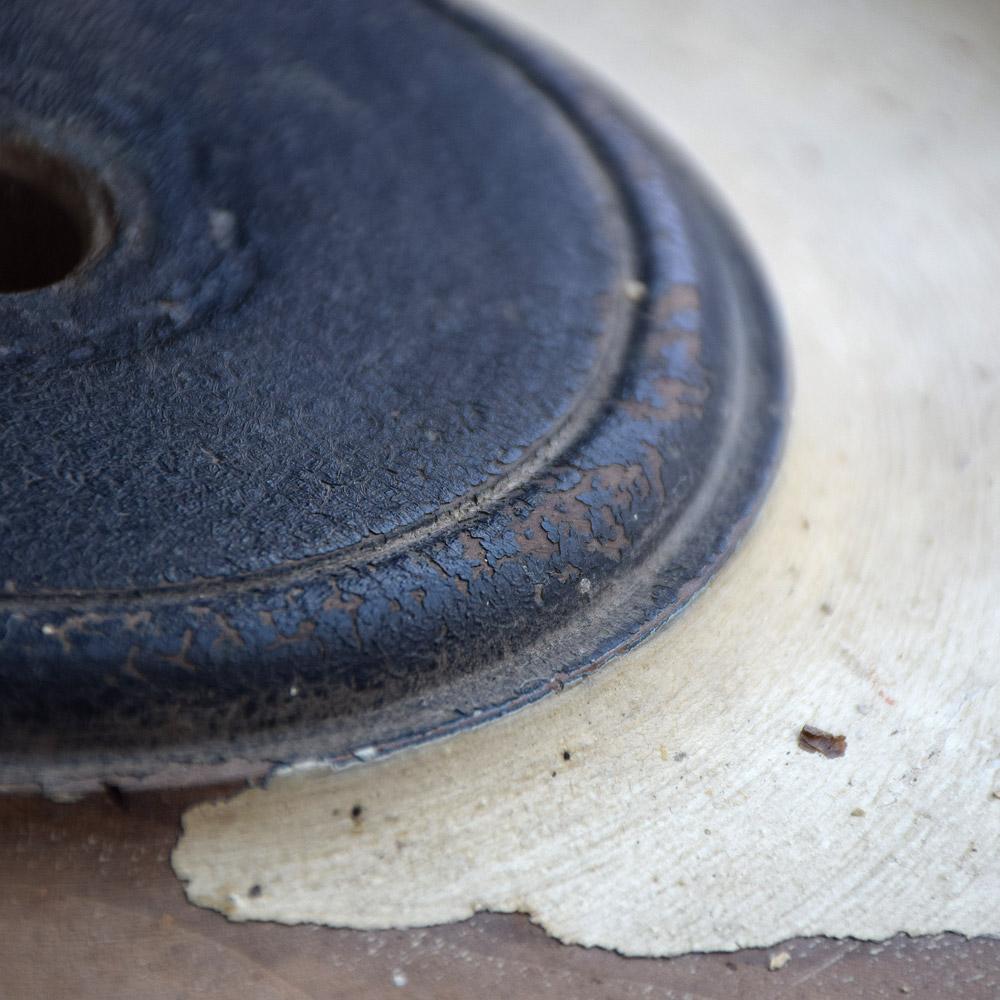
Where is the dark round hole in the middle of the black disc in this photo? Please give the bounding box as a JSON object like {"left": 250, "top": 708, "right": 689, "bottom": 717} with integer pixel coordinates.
{"left": 0, "top": 143, "right": 110, "bottom": 293}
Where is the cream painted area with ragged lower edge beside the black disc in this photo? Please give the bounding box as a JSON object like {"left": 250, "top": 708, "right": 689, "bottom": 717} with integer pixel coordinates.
{"left": 173, "top": 0, "right": 1000, "bottom": 955}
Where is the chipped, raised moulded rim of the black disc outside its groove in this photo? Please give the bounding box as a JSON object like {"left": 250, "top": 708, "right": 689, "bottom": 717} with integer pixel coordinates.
{"left": 0, "top": 0, "right": 788, "bottom": 794}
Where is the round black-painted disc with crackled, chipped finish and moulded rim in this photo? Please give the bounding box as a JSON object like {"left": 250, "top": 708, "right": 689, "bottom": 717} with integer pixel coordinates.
{"left": 0, "top": 0, "right": 784, "bottom": 790}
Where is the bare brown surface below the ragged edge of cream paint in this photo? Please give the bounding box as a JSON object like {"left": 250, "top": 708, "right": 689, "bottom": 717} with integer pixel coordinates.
{"left": 0, "top": 788, "right": 1000, "bottom": 1000}
